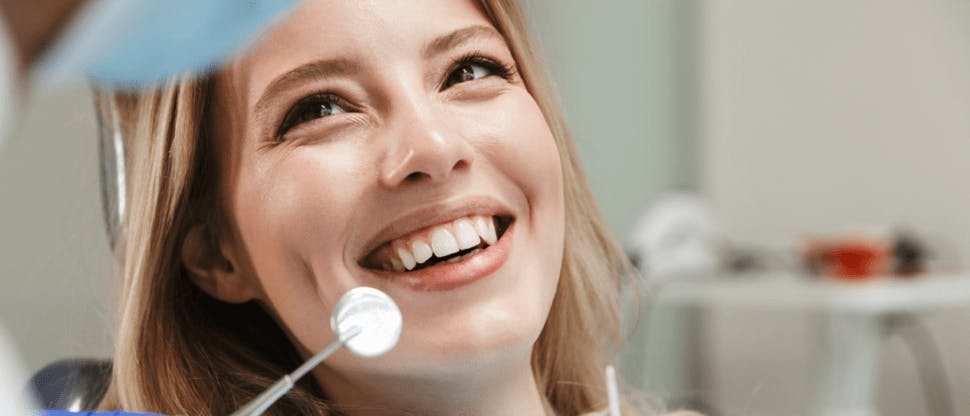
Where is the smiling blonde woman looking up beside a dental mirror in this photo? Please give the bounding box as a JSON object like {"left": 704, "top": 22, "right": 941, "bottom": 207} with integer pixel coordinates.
{"left": 96, "top": 0, "right": 644, "bottom": 415}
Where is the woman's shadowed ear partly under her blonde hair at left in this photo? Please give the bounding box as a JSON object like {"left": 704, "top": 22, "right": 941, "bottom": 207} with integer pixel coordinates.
{"left": 182, "top": 224, "right": 259, "bottom": 303}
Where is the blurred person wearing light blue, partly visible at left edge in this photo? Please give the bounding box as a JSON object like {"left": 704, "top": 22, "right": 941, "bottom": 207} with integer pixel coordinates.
{"left": 0, "top": 0, "right": 295, "bottom": 414}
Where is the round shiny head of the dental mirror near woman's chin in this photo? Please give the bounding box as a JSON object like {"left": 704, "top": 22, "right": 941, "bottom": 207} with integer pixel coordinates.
{"left": 330, "top": 286, "right": 402, "bottom": 357}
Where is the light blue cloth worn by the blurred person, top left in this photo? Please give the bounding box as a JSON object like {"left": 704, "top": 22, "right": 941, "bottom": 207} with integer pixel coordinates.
{"left": 36, "top": 0, "right": 296, "bottom": 87}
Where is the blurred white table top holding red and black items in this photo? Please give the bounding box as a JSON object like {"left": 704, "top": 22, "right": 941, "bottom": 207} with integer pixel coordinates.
{"left": 645, "top": 274, "right": 970, "bottom": 314}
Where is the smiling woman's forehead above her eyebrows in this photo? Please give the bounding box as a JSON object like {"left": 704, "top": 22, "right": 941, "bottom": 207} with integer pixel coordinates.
{"left": 233, "top": 0, "right": 491, "bottom": 105}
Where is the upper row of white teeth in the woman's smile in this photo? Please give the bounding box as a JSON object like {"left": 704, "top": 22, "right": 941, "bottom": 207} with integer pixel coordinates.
{"left": 385, "top": 215, "right": 498, "bottom": 272}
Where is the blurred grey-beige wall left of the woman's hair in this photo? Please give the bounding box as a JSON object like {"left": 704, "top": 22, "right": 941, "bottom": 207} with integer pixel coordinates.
{"left": 0, "top": 85, "right": 113, "bottom": 371}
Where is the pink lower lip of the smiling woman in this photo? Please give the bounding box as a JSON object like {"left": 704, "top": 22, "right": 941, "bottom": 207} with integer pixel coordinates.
{"left": 372, "top": 222, "right": 515, "bottom": 292}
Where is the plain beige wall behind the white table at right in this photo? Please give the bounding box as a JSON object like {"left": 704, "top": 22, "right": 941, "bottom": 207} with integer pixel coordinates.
{"left": 698, "top": 0, "right": 970, "bottom": 415}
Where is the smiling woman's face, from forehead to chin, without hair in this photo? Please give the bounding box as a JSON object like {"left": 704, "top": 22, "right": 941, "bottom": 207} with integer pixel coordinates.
{"left": 210, "top": 0, "right": 564, "bottom": 376}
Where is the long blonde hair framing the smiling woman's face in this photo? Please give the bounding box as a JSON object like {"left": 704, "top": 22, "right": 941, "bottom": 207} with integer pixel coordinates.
{"left": 100, "top": 0, "right": 632, "bottom": 415}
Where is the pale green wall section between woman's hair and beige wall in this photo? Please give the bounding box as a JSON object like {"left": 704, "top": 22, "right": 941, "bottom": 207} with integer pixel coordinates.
{"left": 525, "top": 0, "right": 696, "bottom": 243}
